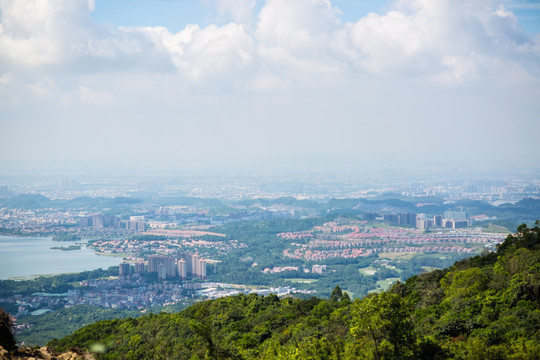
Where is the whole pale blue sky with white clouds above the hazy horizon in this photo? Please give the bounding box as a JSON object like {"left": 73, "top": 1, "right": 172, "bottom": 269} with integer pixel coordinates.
{"left": 0, "top": 0, "right": 540, "bottom": 174}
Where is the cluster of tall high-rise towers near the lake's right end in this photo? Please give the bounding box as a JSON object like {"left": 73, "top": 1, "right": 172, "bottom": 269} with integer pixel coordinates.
{"left": 118, "top": 254, "right": 212, "bottom": 280}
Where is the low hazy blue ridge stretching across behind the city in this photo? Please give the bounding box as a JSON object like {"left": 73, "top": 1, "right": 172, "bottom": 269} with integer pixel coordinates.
{"left": 0, "top": 194, "right": 540, "bottom": 225}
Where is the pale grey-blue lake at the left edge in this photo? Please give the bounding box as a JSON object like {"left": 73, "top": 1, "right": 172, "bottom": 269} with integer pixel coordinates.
{"left": 0, "top": 236, "right": 122, "bottom": 279}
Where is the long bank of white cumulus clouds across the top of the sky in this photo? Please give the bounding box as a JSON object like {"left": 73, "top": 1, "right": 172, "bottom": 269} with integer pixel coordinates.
{"left": 0, "top": 0, "right": 540, "bottom": 84}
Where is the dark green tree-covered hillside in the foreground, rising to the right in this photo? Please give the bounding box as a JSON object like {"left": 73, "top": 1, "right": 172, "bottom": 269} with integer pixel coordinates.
{"left": 49, "top": 222, "right": 540, "bottom": 359}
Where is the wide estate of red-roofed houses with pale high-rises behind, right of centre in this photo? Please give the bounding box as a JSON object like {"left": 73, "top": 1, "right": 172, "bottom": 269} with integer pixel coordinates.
{"left": 278, "top": 219, "right": 506, "bottom": 262}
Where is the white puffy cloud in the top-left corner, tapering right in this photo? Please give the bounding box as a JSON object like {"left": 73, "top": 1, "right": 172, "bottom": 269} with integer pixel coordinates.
{"left": 0, "top": 0, "right": 171, "bottom": 72}
